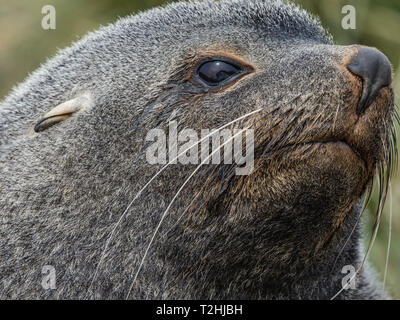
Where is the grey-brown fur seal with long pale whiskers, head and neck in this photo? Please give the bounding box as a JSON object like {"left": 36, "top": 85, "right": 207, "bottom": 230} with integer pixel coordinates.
{"left": 0, "top": 0, "right": 395, "bottom": 299}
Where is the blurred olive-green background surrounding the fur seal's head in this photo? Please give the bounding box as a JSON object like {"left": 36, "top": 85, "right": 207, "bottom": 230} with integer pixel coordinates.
{"left": 0, "top": 0, "right": 400, "bottom": 299}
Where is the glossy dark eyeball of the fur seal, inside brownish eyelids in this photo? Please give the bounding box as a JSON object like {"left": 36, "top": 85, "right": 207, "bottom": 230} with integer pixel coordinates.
{"left": 198, "top": 60, "right": 241, "bottom": 86}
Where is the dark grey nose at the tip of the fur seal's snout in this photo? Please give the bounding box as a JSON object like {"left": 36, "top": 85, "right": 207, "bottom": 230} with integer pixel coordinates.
{"left": 347, "top": 47, "right": 392, "bottom": 114}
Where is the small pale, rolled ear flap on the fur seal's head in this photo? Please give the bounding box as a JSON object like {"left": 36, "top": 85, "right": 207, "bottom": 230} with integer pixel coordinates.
{"left": 33, "top": 93, "right": 92, "bottom": 132}
